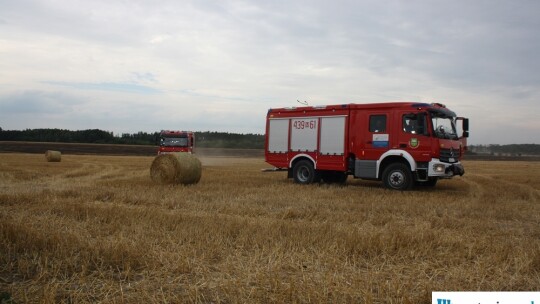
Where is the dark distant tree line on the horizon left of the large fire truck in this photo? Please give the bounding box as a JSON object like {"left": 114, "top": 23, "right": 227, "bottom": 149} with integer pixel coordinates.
{"left": 0, "top": 128, "right": 264, "bottom": 149}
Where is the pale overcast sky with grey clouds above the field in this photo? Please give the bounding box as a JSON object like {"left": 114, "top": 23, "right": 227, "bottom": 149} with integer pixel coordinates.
{"left": 0, "top": 0, "right": 540, "bottom": 144}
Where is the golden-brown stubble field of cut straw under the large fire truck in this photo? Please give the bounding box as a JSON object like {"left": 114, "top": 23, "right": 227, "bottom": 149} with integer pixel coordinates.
{"left": 0, "top": 153, "right": 540, "bottom": 303}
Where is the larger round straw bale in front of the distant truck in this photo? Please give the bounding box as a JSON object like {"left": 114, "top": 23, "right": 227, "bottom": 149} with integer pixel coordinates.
{"left": 150, "top": 153, "right": 202, "bottom": 185}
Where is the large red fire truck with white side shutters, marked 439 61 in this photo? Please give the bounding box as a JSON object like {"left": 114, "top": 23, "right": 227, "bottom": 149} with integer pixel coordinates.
{"left": 265, "top": 102, "right": 469, "bottom": 190}
